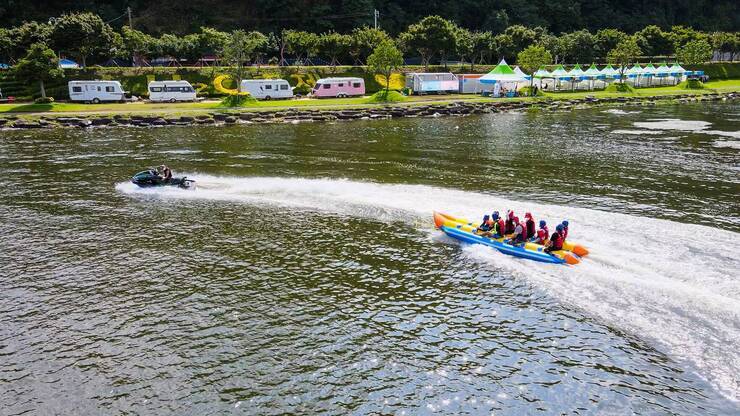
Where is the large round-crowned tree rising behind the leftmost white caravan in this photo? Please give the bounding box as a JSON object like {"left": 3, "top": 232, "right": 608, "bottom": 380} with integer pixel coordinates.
{"left": 49, "top": 13, "right": 116, "bottom": 67}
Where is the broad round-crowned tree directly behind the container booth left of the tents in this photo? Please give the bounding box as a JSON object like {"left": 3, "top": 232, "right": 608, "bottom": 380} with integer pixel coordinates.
{"left": 399, "top": 16, "right": 456, "bottom": 70}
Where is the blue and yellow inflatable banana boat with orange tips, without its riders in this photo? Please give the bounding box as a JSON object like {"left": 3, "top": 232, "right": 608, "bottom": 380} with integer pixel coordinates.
{"left": 434, "top": 212, "right": 581, "bottom": 264}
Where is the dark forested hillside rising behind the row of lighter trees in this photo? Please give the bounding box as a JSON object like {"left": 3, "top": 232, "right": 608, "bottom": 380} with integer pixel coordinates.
{"left": 0, "top": 0, "right": 740, "bottom": 35}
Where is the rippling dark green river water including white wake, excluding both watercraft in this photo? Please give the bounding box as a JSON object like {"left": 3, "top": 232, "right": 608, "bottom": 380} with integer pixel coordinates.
{"left": 0, "top": 103, "right": 740, "bottom": 415}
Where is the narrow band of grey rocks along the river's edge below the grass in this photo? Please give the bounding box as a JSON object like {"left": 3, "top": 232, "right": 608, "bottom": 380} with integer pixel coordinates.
{"left": 0, "top": 92, "right": 740, "bottom": 130}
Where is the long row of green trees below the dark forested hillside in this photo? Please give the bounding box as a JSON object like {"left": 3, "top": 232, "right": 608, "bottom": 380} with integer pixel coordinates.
{"left": 0, "top": 12, "right": 740, "bottom": 70}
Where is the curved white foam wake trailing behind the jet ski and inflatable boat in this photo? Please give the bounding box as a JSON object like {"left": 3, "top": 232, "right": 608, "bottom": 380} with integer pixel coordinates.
{"left": 117, "top": 175, "right": 740, "bottom": 401}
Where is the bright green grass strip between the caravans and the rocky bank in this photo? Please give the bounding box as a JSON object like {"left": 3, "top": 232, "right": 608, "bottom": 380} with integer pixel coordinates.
{"left": 0, "top": 80, "right": 740, "bottom": 114}
